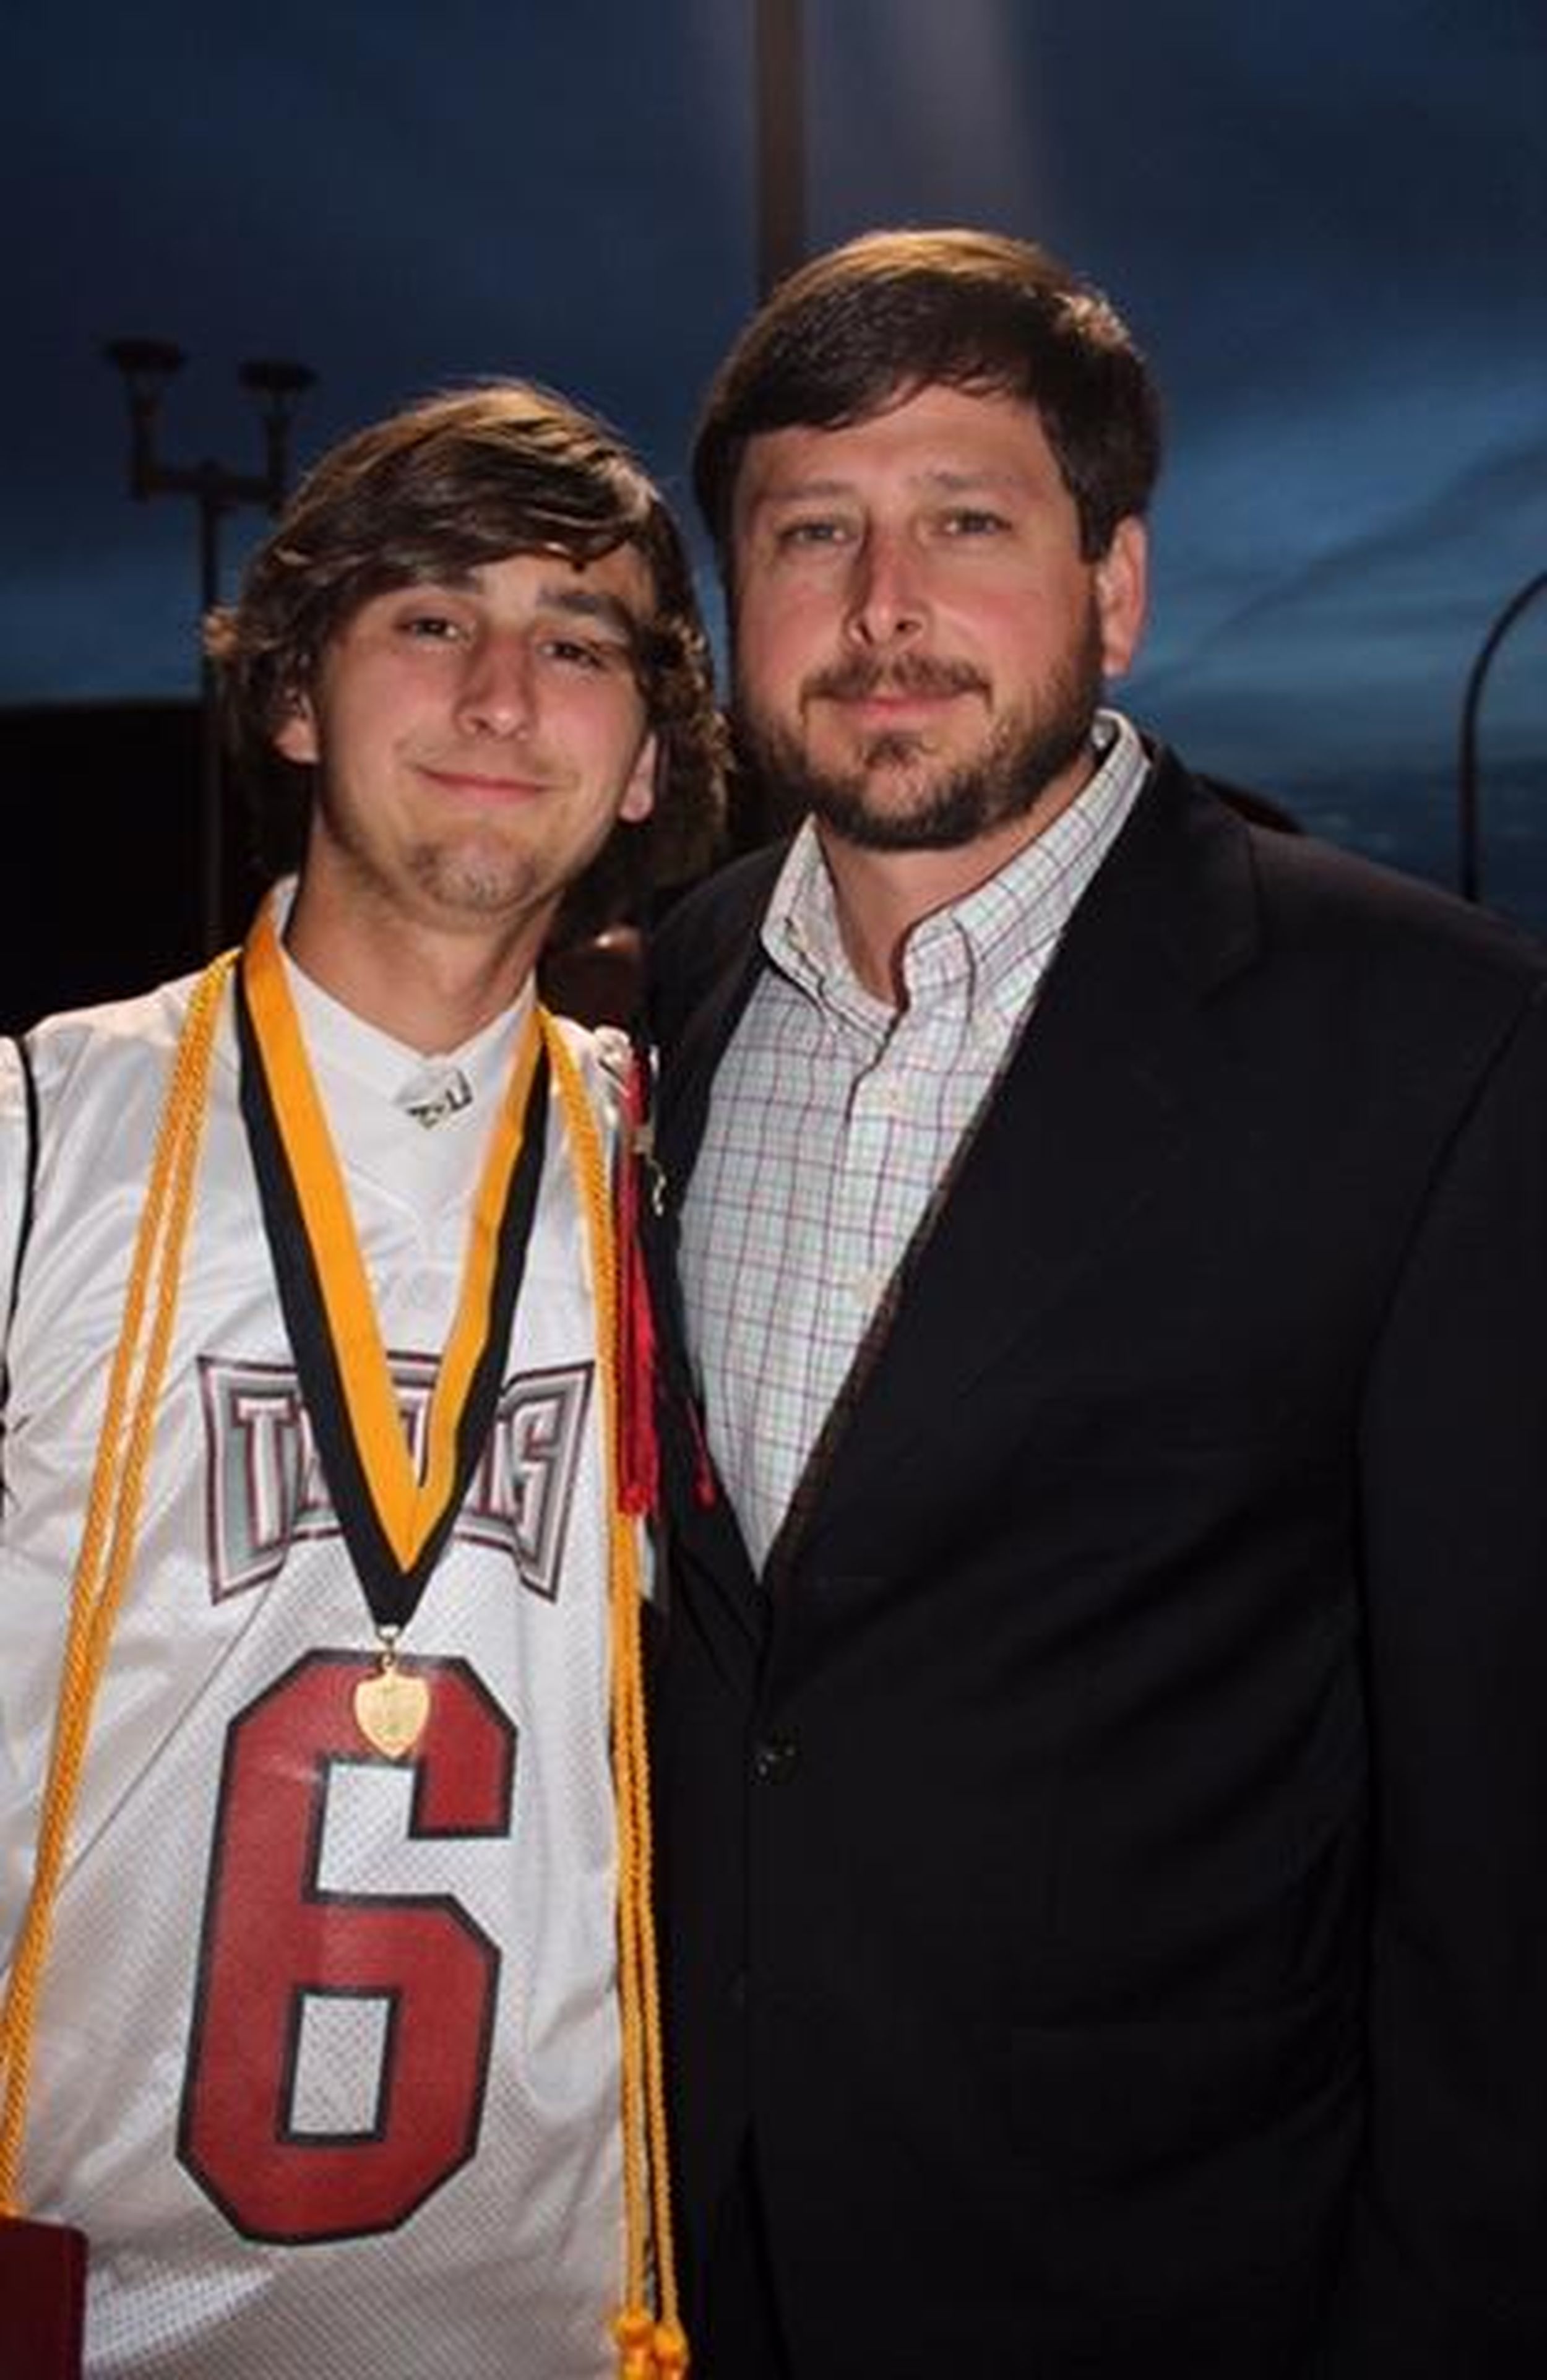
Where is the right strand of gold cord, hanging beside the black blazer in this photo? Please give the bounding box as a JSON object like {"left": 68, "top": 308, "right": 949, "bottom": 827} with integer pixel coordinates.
{"left": 543, "top": 1016, "right": 688, "bottom": 2380}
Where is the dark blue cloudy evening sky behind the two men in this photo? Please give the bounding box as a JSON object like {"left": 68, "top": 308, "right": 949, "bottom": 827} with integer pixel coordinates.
{"left": 0, "top": 0, "right": 1547, "bottom": 928}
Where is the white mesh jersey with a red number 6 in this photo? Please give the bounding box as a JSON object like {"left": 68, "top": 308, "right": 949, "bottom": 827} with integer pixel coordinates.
{"left": 0, "top": 966, "right": 624, "bottom": 2380}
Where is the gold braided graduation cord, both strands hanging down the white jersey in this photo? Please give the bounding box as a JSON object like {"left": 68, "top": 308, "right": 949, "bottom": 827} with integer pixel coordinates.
{"left": 0, "top": 952, "right": 688, "bottom": 2380}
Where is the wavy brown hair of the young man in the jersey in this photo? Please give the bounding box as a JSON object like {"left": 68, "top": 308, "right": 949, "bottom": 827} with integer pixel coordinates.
{"left": 205, "top": 381, "right": 721, "bottom": 878}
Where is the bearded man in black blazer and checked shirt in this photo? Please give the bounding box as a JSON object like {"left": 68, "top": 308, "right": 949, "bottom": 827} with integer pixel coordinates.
{"left": 657, "top": 231, "right": 1547, "bottom": 2380}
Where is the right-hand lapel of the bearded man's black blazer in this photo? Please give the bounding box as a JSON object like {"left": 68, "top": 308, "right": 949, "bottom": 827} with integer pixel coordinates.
{"left": 802, "top": 759, "right": 1257, "bottom": 1547}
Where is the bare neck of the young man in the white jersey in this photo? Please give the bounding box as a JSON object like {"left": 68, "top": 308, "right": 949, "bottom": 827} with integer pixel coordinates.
{"left": 283, "top": 878, "right": 548, "bottom": 1057}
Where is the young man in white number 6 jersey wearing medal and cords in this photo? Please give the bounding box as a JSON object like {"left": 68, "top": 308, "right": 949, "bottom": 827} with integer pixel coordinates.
{"left": 0, "top": 383, "right": 717, "bottom": 2380}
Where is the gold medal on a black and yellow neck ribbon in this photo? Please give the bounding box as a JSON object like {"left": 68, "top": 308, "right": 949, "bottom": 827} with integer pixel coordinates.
{"left": 236, "top": 912, "right": 549, "bottom": 1759}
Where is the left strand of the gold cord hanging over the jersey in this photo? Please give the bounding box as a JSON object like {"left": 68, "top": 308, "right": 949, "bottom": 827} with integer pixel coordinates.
{"left": 0, "top": 952, "right": 236, "bottom": 2216}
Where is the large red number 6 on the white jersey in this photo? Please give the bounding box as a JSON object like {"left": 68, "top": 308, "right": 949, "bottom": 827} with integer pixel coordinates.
{"left": 178, "top": 1652, "right": 517, "bottom": 2242}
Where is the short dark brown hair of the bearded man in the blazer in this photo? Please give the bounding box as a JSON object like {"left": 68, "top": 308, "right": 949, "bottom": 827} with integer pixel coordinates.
{"left": 692, "top": 231, "right": 1161, "bottom": 574}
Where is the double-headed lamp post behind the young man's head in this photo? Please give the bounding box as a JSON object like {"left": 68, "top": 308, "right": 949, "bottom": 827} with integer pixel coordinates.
{"left": 105, "top": 338, "right": 317, "bottom": 954}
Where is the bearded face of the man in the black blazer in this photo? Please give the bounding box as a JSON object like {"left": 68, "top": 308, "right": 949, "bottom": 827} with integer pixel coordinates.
{"left": 733, "top": 386, "right": 1145, "bottom": 871}
